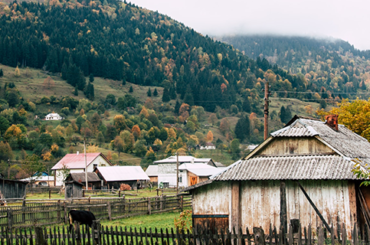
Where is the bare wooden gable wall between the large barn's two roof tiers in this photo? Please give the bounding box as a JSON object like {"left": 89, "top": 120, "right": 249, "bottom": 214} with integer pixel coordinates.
{"left": 257, "top": 138, "right": 334, "bottom": 156}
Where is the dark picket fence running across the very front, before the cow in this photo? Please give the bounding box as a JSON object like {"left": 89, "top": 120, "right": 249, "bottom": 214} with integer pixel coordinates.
{"left": 0, "top": 222, "right": 369, "bottom": 245}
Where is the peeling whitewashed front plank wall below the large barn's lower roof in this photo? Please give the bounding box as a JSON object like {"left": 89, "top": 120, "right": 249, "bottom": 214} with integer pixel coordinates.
{"left": 193, "top": 180, "right": 357, "bottom": 237}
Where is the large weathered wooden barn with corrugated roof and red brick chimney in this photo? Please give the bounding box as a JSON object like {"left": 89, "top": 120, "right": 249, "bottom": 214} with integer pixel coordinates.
{"left": 185, "top": 116, "right": 370, "bottom": 237}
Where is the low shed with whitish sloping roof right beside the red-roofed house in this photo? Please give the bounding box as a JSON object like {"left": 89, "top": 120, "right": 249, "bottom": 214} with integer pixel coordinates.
{"left": 95, "top": 166, "right": 150, "bottom": 189}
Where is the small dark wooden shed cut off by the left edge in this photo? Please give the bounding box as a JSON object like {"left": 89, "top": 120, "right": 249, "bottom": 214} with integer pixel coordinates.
{"left": 0, "top": 177, "right": 29, "bottom": 199}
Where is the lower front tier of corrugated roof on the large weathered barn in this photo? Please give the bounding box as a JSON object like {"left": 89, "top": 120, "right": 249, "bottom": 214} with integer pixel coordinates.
{"left": 211, "top": 156, "right": 356, "bottom": 181}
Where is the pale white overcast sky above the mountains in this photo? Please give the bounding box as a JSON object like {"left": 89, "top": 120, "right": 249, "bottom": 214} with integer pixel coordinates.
{"left": 127, "top": 0, "right": 370, "bottom": 50}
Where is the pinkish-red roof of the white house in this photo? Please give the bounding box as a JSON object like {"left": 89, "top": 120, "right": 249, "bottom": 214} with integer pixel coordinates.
{"left": 52, "top": 152, "right": 112, "bottom": 170}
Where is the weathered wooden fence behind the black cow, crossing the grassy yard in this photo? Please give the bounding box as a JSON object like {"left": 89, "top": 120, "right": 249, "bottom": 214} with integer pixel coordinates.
{"left": 0, "top": 196, "right": 191, "bottom": 229}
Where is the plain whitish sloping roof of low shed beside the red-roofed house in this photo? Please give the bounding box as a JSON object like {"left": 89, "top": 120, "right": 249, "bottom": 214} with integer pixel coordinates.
{"left": 97, "top": 166, "right": 150, "bottom": 181}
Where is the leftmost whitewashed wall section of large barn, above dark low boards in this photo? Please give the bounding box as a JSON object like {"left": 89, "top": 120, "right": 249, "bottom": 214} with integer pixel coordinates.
{"left": 193, "top": 182, "right": 231, "bottom": 215}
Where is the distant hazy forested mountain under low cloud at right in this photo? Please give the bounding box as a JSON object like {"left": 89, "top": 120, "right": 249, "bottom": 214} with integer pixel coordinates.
{"left": 216, "top": 35, "right": 370, "bottom": 99}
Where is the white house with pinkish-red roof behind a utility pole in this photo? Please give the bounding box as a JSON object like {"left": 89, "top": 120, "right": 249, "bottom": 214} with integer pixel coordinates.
{"left": 51, "top": 152, "right": 112, "bottom": 186}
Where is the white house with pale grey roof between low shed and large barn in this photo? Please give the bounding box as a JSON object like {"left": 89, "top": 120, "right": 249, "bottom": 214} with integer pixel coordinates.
{"left": 153, "top": 156, "right": 216, "bottom": 187}
